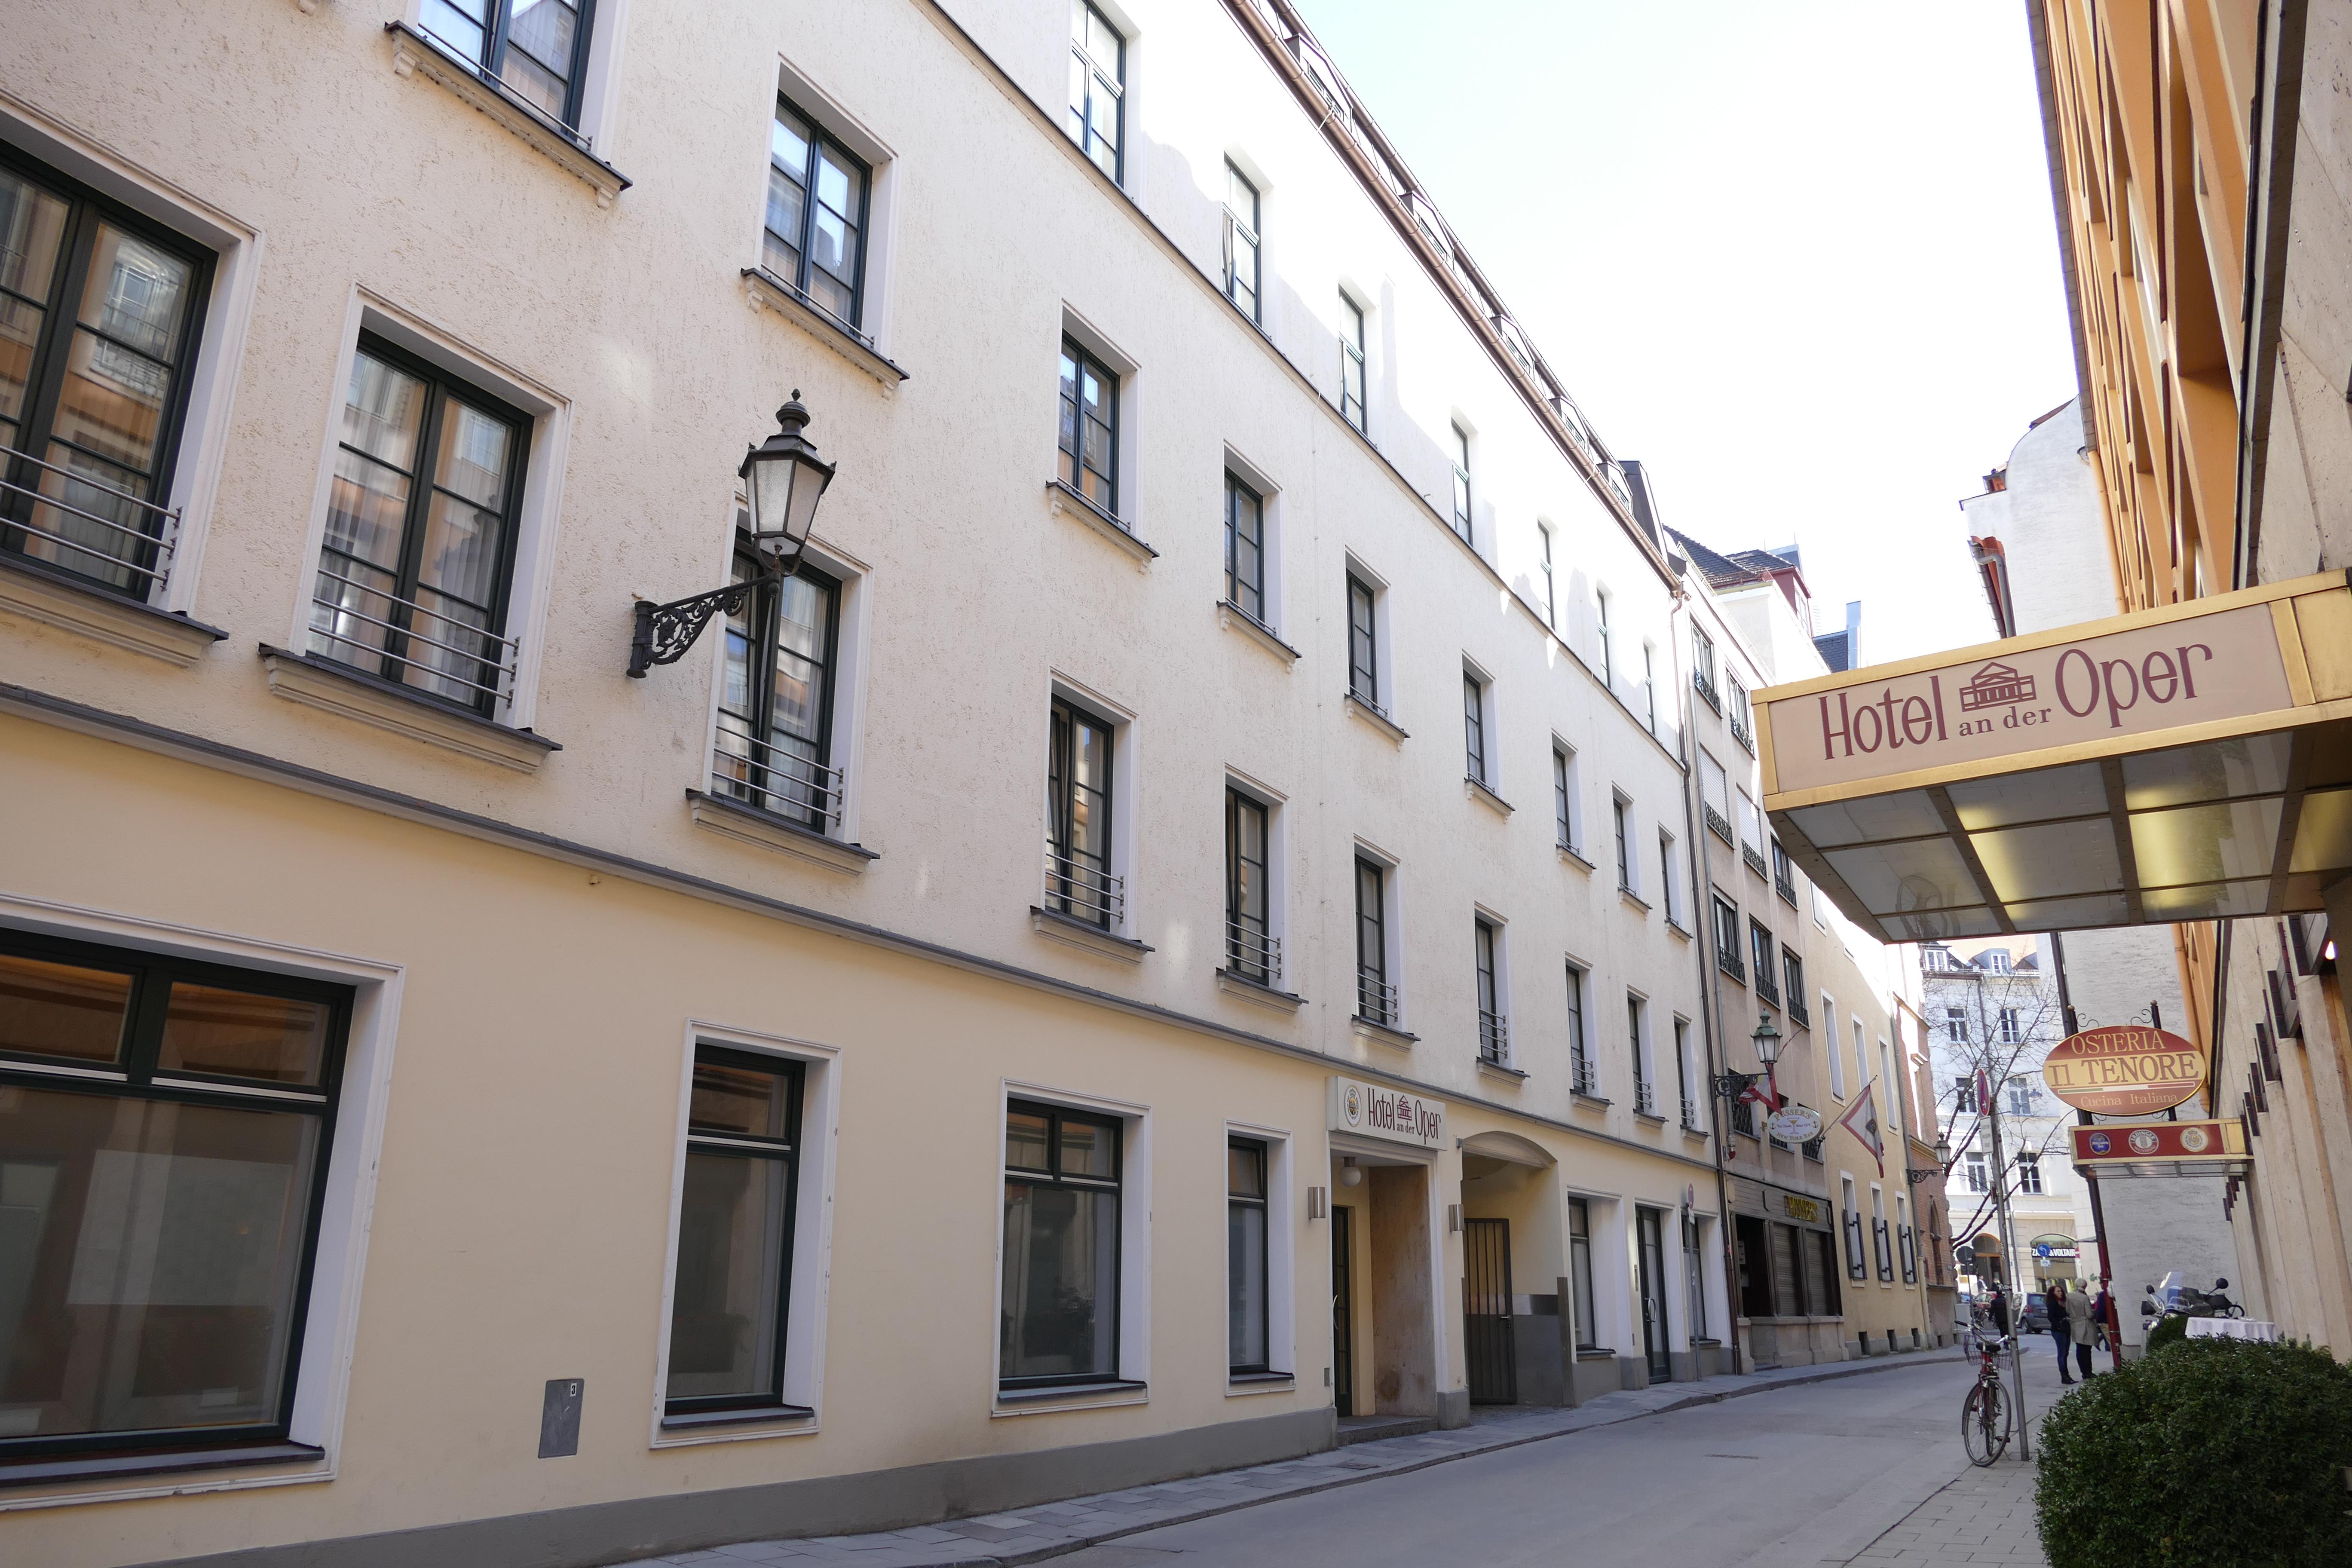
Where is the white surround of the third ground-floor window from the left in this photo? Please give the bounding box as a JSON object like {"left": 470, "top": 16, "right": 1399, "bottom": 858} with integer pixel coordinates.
{"left": 988, "top": 1079, "right": 1152, "bottom": 1420}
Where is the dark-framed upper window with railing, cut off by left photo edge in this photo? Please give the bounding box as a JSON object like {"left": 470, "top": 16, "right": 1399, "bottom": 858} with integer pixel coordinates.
{"left": 0, "top": 153, "right": 211, "bottom": 600}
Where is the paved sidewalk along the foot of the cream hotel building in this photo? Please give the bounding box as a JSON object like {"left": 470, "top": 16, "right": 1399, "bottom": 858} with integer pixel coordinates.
{"left": 626, "top": 1349, "right": 1957, "bottom": 1568}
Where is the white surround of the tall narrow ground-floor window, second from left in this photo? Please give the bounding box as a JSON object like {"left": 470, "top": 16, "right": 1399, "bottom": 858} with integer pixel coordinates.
{"left": 647, "top": 1018, "right": 846, "bottom": 1448}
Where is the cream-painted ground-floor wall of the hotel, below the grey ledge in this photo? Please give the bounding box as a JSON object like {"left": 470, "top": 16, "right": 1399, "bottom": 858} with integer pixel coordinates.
{"left": 0, "top": 717, "right": 1731, "bottom": 1568}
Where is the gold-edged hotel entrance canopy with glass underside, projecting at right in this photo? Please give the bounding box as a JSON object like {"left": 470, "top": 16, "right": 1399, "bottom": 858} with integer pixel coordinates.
{"left": 1755, "top": 571, "right": 2352, "bottom": 943}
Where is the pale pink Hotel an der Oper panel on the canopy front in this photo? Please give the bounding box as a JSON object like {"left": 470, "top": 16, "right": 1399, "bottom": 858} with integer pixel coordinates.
{"left": 1771, "top": 604, "right": 2296, "bottom": 795}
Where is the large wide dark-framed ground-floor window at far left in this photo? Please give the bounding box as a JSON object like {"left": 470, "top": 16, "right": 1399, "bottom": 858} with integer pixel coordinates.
{"left": 0, "top": 936, "right": 350, "bottom": 1472}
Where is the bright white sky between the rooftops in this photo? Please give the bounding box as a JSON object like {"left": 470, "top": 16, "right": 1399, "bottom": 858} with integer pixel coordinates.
{"left": 1301, "top": 0, "right": 2074, "bottom": 663}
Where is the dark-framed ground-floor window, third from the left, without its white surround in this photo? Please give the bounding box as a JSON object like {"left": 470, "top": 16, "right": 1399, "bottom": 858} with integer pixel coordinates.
{"left": 997, "top": 1100, "right": 1122, "bottom": 1389}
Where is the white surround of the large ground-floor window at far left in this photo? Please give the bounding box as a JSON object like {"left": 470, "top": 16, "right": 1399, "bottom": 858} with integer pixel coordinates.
{"left": 0, "top": 893, "right": 407, "bottom": 1514}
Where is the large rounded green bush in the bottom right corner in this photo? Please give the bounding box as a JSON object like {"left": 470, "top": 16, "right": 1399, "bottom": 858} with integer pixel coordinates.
{"left": 2034, "top": 1338, "right": 2352, "bottom": 1568}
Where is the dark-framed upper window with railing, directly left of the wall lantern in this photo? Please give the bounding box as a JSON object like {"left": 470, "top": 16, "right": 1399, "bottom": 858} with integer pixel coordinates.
{"left": 310, "top": 334, "right": 529, "bottom": 715}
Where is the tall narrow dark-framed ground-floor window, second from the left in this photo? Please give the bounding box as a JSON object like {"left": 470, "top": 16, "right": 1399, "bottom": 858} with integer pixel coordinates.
{"left": 666, "top": 1046, "right": 802, "bottom": 1418}
